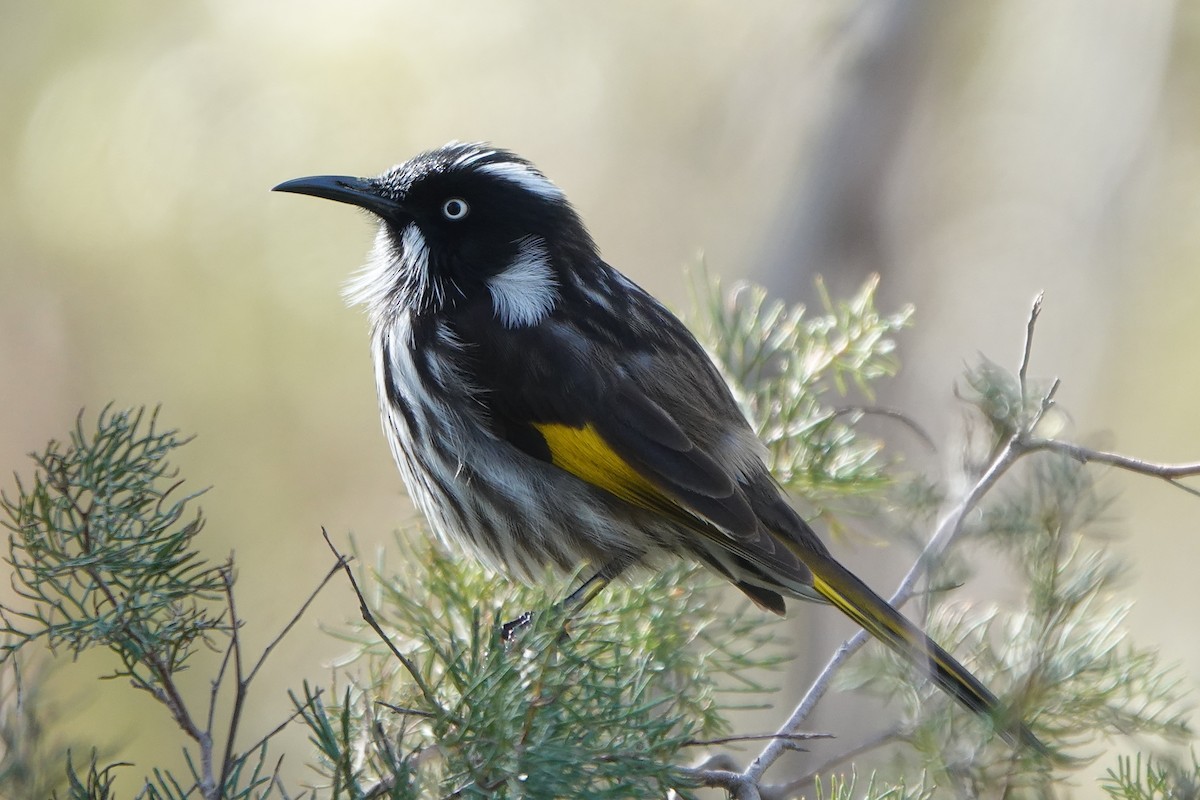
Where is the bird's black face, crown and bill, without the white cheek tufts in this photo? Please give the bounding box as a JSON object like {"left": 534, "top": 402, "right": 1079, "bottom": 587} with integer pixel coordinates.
{"left": 275, "top": 144, "right": 594, "bottom": 287}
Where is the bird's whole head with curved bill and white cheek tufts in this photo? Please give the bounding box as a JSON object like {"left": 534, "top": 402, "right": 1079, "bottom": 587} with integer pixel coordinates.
{"left": 275, "top": 143, "right": 598, "bottom": 327}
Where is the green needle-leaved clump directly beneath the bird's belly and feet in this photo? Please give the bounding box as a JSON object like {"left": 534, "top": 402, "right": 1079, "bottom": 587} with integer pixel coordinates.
{"left": 296, "top": 537, "right": 779, "bottom": 798}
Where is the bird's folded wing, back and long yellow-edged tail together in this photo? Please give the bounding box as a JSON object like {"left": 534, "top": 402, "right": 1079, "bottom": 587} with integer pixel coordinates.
{"left": 446, "top": 287, "right": 1043, "bottom": 750}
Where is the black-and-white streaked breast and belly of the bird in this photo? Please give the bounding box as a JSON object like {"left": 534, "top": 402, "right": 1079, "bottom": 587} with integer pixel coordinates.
{"left": 372, "top": 299, "right": 657, "bottom": 582}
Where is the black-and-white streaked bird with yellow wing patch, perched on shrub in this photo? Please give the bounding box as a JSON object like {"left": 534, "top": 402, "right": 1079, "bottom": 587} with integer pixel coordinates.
{"left": 274, "top": 142, "right": 1045, "bottom": 752}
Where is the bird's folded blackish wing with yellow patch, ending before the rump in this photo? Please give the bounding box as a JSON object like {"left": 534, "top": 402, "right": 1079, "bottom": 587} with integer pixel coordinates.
{"left": 460, "top": 280, "right": 766, "bottom": 541}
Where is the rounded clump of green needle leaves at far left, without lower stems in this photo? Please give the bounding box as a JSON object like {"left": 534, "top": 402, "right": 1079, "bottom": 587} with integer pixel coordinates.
{"left": 0, "top": 409, "right": 227, "bottom": 692}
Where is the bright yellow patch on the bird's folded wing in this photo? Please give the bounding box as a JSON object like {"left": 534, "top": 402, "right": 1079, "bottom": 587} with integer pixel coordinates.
{"left": 533, "top": 422, "right": 683, "bottom": 516}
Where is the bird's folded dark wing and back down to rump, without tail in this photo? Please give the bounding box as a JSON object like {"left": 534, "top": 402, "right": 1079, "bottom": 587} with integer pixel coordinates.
{"left": 441, "top": 278, "right": 822, "bottom": 613}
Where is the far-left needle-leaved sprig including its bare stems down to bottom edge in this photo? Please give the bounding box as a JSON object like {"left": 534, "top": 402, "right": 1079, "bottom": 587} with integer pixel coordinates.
{"left": 0, "top": 409, "right": 282, "bottom": 800}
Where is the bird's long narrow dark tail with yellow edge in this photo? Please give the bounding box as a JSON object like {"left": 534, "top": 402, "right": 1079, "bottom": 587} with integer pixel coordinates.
{"left": 796, "top": 549, "right": 1049, "bottom": 754}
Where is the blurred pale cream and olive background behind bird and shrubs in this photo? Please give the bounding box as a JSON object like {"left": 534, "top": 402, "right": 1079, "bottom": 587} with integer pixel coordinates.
{"left": 0, "top": 0, "right": 1200, "bottom": 798}
